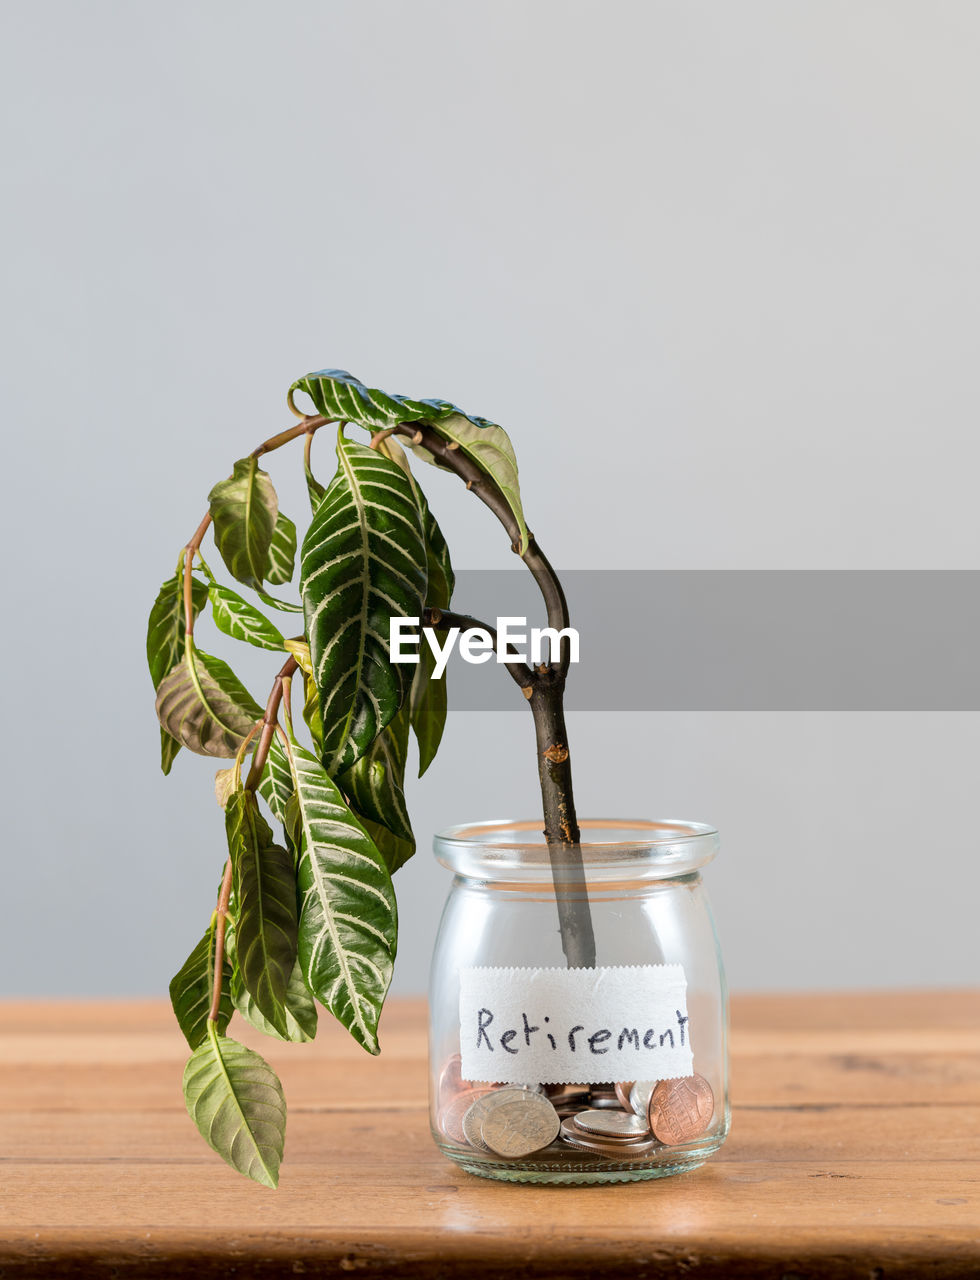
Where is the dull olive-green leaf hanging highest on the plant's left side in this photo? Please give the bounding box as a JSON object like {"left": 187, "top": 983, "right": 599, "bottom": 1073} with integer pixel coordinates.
{"left": 209, "top": 456, "right": 279, "bottom": 586}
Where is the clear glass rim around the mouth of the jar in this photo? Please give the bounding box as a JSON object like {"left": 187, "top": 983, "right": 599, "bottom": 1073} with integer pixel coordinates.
{"left": 432, "top": 818, "right": 719, "bottom": 879}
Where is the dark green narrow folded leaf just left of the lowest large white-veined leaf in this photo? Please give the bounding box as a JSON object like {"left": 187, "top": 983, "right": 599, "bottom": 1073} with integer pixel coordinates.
{"left": 225, "top": 790, "right": 297, "bottom": 1036}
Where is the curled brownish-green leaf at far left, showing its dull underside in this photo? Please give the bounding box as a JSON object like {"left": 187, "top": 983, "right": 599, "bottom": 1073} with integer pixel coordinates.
{"left": 156, "top": 644, "right": 262, "bottom": 756}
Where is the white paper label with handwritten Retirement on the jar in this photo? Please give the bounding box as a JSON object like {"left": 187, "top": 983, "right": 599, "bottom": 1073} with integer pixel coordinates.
{"left": 459, "top": 964, "right": 693, "bottom": 1084}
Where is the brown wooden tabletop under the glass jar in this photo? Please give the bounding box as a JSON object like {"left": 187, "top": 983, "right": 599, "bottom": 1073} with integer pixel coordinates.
{"left": 0, "top": 992, "right": 980, "bottom": 1280}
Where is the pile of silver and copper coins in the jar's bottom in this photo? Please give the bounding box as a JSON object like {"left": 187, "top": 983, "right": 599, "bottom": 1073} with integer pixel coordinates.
{"left": 439, "top": 1053, "right": 714, "bottom": 1162}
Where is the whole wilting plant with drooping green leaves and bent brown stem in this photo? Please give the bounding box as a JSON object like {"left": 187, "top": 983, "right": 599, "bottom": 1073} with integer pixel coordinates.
{"left": 146, "top": 370, "right": 595, "bottom": 1187}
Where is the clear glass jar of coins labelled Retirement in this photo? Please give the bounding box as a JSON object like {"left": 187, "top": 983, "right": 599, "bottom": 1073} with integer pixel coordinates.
{"left": 429, "top": 819, "right": 731, "bottom": 1184}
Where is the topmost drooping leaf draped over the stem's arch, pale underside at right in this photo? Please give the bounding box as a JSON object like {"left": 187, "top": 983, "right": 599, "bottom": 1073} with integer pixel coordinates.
{"left": 289, "top": 369, "right": 528, "bottom": 554}
